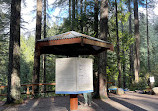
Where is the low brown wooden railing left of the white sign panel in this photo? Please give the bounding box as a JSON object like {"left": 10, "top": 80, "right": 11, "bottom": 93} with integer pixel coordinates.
{"left": 0, "top": 83, "right": 56, "bottom": 96}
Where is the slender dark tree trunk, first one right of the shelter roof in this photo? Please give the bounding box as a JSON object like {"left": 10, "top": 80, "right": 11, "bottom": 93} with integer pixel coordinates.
{"left": 115, "top": 0, "right": 121, "bottom": 87}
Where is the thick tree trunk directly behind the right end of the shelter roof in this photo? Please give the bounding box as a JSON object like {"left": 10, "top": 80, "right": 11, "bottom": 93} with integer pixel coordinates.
{"left": 99, "top": 0, "right": 108, "bottom": 99}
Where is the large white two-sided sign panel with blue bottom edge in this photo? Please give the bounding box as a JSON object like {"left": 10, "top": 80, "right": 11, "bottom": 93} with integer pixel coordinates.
{"left": 56, "top": 58, "right": 93, "bottom": 94}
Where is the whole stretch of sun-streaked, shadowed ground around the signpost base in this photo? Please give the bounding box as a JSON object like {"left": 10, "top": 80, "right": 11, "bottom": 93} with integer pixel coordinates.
{"left": 0, "top": 92, "right": 158, "bottom": 111}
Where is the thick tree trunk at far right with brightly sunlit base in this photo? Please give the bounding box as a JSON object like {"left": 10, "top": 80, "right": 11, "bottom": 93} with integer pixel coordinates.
{"left": 134, "top": 0, "right": 140, "bottom": 83}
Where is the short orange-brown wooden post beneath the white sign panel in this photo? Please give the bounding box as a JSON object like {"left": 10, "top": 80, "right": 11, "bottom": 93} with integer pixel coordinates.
{"left": 70, "top": 94, "right": 78, "bottom": 111}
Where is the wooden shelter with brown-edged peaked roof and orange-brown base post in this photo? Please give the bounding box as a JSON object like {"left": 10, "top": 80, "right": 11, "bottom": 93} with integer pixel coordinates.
{"left": 34, "top": 31, "right": 113, "bottom": 110}
